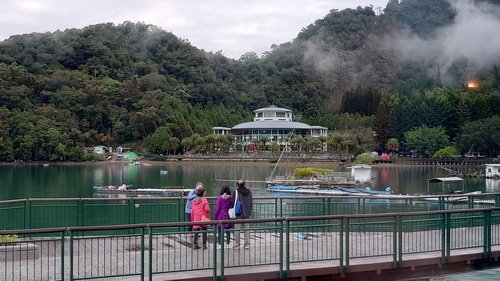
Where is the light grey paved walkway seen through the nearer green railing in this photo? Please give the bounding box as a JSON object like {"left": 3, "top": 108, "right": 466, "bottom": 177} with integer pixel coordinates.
{"left": 0, "top": 225, "right": 500, "bottom": 280}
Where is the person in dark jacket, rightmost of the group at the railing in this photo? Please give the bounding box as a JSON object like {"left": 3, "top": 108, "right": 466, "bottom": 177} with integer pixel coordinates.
{"left": 233, "top": 179, "right": 253, "bottom": 249}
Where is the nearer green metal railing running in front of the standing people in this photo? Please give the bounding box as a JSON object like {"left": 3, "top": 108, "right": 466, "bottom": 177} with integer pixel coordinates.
{"left": 0, "top": 208, "right": 500, "bottom": 280}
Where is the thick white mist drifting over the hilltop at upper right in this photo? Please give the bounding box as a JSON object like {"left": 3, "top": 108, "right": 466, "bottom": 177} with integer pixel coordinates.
{"left": 386, "top": 0, "right": 500, "bottom": 86}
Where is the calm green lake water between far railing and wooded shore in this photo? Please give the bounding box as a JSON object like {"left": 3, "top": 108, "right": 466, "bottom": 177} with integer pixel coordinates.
{"left": 0, "top": 162, "right": 500, "bottom": 200}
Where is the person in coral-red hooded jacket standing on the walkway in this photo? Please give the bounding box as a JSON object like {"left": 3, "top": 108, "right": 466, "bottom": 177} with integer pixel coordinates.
{"left": 191, "top": 187, "right": 210, "bottom": 250}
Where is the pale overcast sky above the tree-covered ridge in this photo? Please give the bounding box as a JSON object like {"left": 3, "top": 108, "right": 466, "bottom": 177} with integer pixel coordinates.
{"left": 0, "top": 0, "right": 387, "bottom": 59}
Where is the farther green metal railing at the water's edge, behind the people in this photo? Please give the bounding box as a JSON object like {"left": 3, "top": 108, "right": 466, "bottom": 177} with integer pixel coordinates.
{"left": 0, "top": 193, "right": 500, "bottom": 230}
